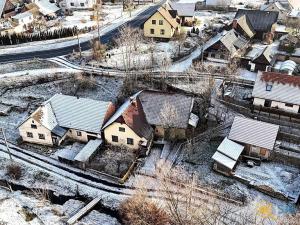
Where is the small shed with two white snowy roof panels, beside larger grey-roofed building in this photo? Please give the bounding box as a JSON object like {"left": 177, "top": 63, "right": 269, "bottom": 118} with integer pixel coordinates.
{"left": 212, "top": 137, "right": 244, "bottom": 176}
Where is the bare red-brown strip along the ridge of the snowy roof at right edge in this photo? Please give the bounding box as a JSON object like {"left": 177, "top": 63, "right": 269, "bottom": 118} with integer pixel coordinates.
{"left": 261, "top": 72, "right": 300, "bottom": 87}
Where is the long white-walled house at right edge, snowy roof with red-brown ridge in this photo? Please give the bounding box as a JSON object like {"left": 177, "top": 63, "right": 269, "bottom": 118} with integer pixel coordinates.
{"left": 252, "top": 72, "right": 300, "bottom": 113}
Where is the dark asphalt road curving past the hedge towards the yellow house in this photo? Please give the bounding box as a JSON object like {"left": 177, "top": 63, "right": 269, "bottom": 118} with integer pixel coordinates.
{"left": 0, "top": 4, "right": 160, "bottom": 63}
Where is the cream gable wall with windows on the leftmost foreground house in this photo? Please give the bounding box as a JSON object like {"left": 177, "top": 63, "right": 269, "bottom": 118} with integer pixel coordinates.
{"left": 19, "top": 118, "right": 53, "bottom": 146}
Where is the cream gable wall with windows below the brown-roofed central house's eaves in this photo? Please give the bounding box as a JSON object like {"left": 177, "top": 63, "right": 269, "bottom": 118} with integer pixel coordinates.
{"left": 104, "top": 122, "right": 146, "bottom": 149}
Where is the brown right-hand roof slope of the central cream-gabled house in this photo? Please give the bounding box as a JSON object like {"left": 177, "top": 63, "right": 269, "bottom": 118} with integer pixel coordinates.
{"left": 118, "top": 97, "right": 153, "bottom": 139}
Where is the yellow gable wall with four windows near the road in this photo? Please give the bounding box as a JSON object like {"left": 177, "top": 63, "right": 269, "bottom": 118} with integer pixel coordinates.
{"left": 144, "top": 12, "right": 175, "bottom": 39}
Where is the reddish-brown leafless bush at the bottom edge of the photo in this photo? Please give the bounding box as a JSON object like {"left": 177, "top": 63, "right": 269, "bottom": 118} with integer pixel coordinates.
{"left": 119, "top": 195, "right": 170, "bottom": 225}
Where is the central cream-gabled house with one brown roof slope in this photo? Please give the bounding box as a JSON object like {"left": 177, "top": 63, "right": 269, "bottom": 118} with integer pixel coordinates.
{"left": 103, "top": 92, "right": 153, "bottom": 150}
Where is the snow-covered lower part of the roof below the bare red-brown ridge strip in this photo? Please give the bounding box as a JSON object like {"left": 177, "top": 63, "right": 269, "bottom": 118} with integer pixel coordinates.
{"left": 252, "top": 72, "right": 300, "bottom": 105}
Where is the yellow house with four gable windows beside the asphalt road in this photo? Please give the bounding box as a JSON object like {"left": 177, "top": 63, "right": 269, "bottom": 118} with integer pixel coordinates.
{"left": 144, "top": 7, "right": 180, "bottom": 39}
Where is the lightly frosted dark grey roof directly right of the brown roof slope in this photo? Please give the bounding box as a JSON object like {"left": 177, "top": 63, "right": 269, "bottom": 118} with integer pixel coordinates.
{"left": 139, "top": 91, "right": 194, "bottom": 128}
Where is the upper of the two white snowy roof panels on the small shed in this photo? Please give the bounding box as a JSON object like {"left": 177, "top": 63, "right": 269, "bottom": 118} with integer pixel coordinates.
{"left": 218, "top": 137, "right": 244, "bottom": 160}
